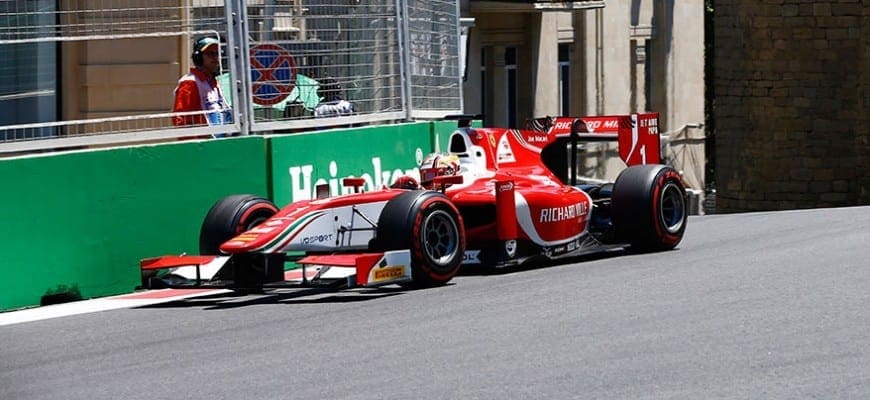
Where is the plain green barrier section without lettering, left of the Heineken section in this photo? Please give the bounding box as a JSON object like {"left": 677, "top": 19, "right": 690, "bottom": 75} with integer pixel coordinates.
{"left": 0, "top": 136, "right": 268, "bottom": 310}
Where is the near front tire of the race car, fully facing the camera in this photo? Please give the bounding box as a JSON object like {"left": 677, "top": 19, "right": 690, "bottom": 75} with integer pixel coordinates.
{"left": 372, "top": 190, "right": 465, "bottom": 288}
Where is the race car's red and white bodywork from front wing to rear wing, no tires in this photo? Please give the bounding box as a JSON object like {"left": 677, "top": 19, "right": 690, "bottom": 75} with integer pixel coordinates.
{"left": 142, "top": 113, "right": 660, "bottom": 285}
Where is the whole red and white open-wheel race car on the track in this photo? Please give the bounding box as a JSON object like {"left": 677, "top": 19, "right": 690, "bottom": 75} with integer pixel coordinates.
{"left": 141, "top": 114, "right": 687, "bottom": 288}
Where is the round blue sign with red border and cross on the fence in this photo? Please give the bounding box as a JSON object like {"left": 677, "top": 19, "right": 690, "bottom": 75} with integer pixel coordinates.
{"left": 251, "top": 44, "right": 296, "bottom": 106}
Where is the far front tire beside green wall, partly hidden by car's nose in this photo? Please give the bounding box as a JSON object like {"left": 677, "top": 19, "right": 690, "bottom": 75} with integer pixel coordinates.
{"left": 199, "top": 194, "right": 284, "bottom": 287}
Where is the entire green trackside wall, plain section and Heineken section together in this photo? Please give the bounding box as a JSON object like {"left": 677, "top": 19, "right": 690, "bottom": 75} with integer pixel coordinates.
{"left": 0, "top": 122, "right": 436, "bottom": 311}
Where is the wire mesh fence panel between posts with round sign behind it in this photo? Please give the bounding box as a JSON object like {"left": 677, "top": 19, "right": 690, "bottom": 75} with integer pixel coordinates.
{"left": 247, "top": 0, "right": 406, "bottom": 129}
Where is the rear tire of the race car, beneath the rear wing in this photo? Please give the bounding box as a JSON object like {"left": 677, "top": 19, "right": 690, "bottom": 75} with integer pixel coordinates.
{"left": 611, "top": 164, "right": 688, "bottom": 252}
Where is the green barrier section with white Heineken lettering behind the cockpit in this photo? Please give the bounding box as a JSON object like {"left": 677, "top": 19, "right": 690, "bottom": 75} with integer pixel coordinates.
{"left": 270, "top": 122, "right": 434, "bottom": 206}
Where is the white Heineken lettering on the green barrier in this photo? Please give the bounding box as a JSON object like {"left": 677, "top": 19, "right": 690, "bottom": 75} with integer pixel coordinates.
{"left": 287, "top": 155, "right": 422, "bottom": 201}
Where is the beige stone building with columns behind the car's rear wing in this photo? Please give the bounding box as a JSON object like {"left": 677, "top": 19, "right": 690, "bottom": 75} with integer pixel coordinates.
{"left": 460, "top": 0, "right": 706, "bottom": 194}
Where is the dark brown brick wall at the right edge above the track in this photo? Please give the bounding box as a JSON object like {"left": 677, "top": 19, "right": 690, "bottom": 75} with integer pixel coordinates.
{"left": 714, "top": 0, "right": 870, "bottom": 212}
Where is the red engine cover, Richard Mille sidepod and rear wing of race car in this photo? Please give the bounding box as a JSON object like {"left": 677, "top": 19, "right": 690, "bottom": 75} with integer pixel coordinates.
{"left": 436, "top": 113, "right": 660, "bottom": 250}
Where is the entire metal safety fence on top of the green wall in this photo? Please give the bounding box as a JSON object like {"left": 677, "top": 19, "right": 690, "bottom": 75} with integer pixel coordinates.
{"left": 0, "top": 0, "right": 462, "bottom": 156}
